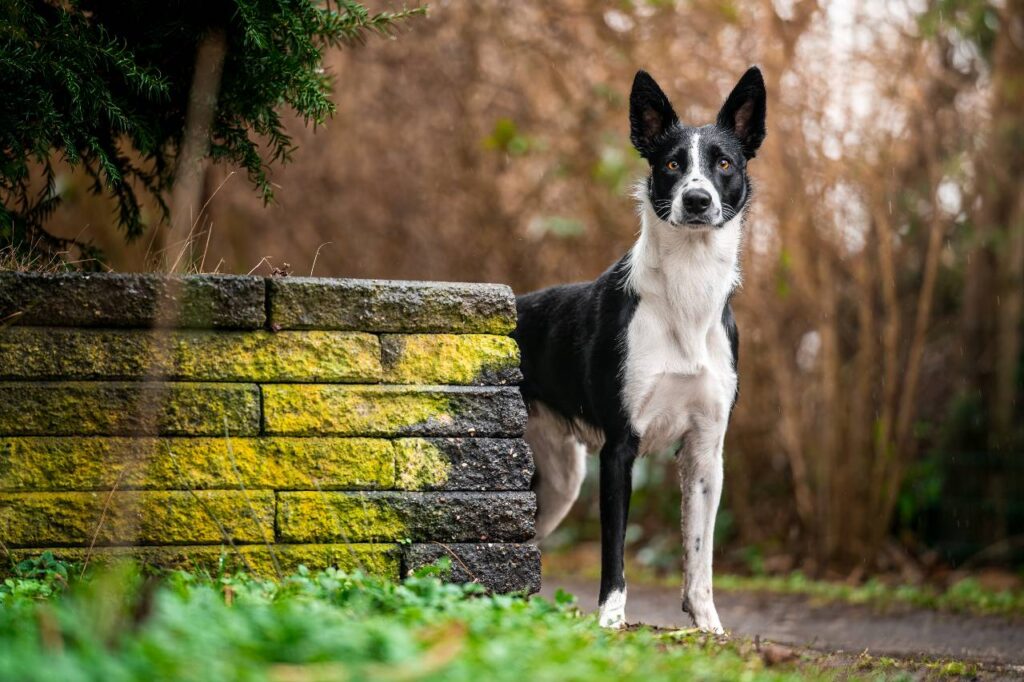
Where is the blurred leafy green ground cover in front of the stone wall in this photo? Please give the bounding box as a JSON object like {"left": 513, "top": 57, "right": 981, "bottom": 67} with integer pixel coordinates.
{"left": 0, "top": 557, "right": 851, "bottom": 682}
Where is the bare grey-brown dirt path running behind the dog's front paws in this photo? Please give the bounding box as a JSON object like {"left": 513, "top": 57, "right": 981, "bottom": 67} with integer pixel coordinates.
{"left": 541, "top": 576, "right": 1024, "bottom": 677}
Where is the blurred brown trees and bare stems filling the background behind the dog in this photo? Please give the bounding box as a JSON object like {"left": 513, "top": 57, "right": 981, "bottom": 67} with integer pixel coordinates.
{"left": 8, "top": 0, "right": 1024, "bottom": 579}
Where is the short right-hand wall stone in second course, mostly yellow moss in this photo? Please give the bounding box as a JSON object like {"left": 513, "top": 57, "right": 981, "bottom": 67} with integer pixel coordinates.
{"left": 381, "top": 334, "right": 522, "bottom": 386}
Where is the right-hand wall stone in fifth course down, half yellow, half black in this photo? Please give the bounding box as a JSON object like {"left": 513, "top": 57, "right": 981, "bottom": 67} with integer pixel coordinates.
{"left": 276, "top": 493, "right": 537, "bottom": 543}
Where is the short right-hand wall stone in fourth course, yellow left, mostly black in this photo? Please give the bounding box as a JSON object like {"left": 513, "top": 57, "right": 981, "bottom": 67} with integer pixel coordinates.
{"left": 393, "top": 438, "right": 534, "bottom": 491}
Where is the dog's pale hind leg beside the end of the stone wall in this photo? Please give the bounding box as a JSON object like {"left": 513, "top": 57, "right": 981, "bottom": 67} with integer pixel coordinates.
{"left": 525, "top": 402, "right": 587, "bottom": 542}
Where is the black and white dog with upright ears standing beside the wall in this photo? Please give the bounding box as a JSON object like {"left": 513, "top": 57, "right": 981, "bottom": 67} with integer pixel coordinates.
{"left": 515, "top": 68, "right": 766, "bottom": 633}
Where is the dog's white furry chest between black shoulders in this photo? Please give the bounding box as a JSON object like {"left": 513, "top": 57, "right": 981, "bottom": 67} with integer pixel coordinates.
{"left": 623, "top": 218, "right": 738, "bottom": 454}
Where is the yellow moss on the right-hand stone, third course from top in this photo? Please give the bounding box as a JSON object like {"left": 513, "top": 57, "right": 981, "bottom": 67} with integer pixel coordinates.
{"left": 262, "top": 384, "right": 453, "bottom": 435}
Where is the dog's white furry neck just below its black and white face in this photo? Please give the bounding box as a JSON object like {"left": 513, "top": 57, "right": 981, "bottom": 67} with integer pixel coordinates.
{"left": 626, "top": 198, "right": 742, "bottom": 309}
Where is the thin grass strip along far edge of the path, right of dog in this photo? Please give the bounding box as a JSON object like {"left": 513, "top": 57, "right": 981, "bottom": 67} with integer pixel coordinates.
{"left": 715, "top": 571, "right": 1024, "bottom": 615}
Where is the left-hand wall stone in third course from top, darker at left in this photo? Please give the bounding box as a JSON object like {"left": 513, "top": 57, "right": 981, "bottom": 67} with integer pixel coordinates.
{"left": 0, "top": 382, "right": 260, "bottom": 435}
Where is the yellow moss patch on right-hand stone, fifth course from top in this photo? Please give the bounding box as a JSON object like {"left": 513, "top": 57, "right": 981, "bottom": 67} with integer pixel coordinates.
{"left": 278, "top": 492, "right": 409, "bottom": 543}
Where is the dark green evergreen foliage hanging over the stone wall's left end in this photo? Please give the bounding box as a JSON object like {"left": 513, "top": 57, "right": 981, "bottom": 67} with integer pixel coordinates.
{"left": 0, "top": 0, "right": 424, "bottom": 248}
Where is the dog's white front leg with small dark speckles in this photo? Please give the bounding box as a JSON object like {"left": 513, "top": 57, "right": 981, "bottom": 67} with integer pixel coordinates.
{"left": 677, "top": 418, "right": 725, "bottom": 635}
